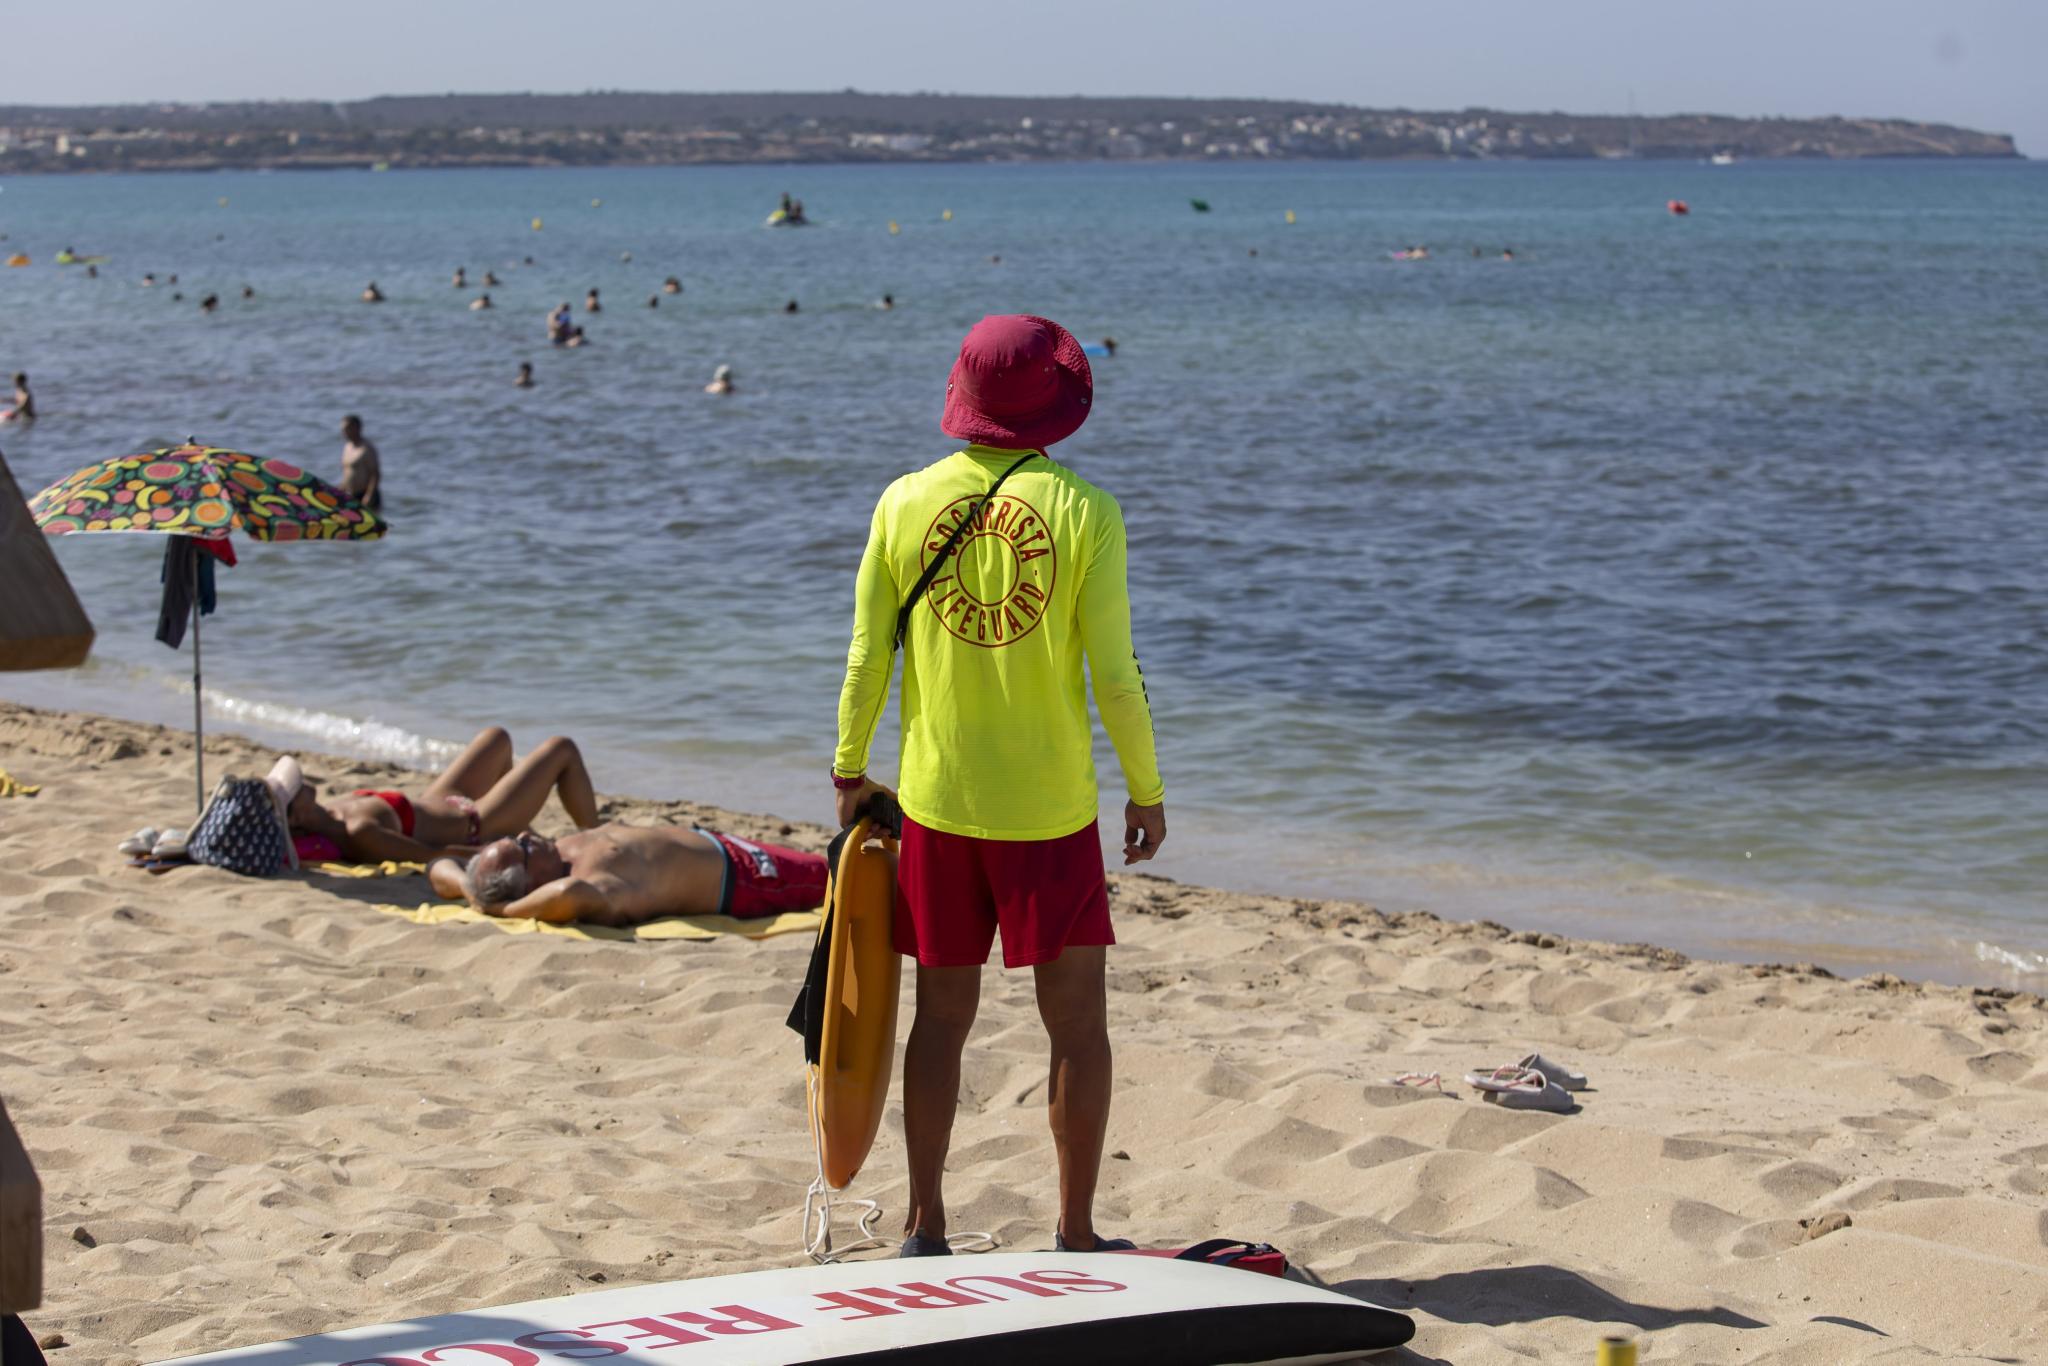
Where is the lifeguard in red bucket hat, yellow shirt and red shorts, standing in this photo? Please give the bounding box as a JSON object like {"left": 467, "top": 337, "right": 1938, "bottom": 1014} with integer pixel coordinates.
{"left": 831, "top": 315, "right": 1165, "bottom": 1257}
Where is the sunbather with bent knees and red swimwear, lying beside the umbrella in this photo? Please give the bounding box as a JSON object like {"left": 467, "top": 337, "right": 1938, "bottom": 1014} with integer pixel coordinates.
{"left": 268, "top": 725, "right": 598, "bottom": 862}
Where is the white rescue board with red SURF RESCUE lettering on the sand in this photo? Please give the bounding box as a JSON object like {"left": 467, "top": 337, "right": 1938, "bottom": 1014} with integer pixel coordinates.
{"left": 159, "top": 1251, "right": 1415, "bottom": 1366}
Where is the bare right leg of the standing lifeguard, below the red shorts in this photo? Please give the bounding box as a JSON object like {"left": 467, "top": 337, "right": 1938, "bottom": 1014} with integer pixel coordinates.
{"left": 1032, "top": 946, "right": 1110, "bottom": 1251}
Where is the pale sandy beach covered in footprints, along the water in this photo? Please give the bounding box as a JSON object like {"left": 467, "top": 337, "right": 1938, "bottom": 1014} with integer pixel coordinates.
{"left": 0, "top": 705, "right": 2048, "bottom": 1364}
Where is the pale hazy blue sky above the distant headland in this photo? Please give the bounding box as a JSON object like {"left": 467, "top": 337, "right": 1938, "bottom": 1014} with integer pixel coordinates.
{"left": 0, "top": 0, "right": 2048, "bottom": 156}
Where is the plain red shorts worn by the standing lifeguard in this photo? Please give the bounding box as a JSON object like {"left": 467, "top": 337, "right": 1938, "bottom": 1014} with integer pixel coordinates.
{"left": 895, "top": 815, "right": 1116, "bottom": 967}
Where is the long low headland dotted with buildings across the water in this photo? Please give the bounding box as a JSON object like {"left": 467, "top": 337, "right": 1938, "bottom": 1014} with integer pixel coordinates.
{"left": 0, "top": 90, "right": 2019, "bottom": 172}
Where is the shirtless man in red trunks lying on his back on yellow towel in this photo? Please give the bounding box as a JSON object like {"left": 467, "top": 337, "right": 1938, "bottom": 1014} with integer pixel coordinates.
{"left": 426, "top": 823, "right": 825, "bottom": 926}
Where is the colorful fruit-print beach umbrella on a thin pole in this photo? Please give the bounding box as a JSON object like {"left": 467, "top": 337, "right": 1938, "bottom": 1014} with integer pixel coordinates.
{"left": 29, "top": 442, "right": 389, "bottom": 809}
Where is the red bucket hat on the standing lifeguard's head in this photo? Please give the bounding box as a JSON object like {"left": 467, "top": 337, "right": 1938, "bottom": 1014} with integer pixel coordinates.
{"left": 938, "top": 313, "right": 1096, "bottom": 451}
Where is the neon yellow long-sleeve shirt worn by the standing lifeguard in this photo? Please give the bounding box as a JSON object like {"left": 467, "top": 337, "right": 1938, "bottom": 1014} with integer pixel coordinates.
{"left": 834, "top": 446, "right": 1165, "bottom": 840}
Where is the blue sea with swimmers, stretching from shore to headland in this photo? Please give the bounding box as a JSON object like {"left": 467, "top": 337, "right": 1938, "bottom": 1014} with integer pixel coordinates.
{"left": 0, "top": 162, "right": 2048, "bottom": 987}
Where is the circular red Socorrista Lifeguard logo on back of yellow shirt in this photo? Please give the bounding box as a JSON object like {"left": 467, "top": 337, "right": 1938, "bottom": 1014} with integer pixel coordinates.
{"left": 920, "top": 494, "right": 1059, "bottom": 649}
